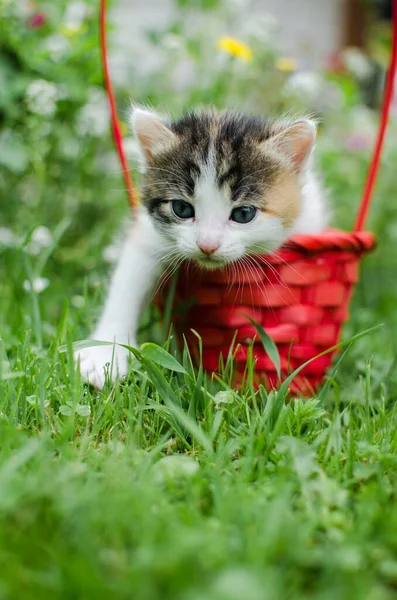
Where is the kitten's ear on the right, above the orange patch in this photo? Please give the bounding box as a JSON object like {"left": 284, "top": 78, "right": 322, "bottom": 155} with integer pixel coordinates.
{"left": 261, "top": 119, "right": 316, "bottom": 171}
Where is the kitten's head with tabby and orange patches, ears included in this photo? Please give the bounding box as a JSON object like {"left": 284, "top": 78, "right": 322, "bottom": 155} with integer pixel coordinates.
{"left": 131, "top": 108, "right": 316, "bottom": 268}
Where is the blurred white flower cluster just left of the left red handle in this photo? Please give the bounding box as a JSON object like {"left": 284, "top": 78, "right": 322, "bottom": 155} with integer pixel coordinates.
{"left": 76, "top": 88, "right": 109, "bottom": 137}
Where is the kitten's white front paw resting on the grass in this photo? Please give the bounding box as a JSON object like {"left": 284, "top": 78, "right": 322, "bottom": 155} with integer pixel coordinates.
{"left": 74, "top": 345, "right": 130, "bottom": 390}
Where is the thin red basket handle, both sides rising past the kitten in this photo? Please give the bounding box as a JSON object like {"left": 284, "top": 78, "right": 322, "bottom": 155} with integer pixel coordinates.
{"left": 100, "top": 0, "right": 397, "bottom": 231}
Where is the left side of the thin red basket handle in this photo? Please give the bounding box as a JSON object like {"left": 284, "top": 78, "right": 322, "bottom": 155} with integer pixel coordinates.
{"left": 99, "top": 0, "right": 137, "bottom": 210}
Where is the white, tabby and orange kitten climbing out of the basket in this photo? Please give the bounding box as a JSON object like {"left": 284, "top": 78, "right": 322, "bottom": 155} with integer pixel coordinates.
{"left": 76, "top": 108, "right": 327, "bottom": 388}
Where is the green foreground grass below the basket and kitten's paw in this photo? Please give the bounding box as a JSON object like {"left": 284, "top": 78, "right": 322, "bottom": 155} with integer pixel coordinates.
{"left": 0, "top": 328, "right": 397, "bottom": 600}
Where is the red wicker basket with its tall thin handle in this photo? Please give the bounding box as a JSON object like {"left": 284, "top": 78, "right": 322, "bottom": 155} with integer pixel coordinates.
{"left": 100, "top": 0, "right": 397, "bottom": 393}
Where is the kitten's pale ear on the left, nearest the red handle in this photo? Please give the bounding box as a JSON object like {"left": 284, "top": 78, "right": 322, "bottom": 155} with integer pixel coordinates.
{"left": 130, "top": 108, "right": 176, "bottom": 164}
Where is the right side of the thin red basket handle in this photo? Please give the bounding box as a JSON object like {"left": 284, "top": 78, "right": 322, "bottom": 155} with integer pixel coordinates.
{"left": 354, "top": 0, "right": 397, "bottom": 231}
